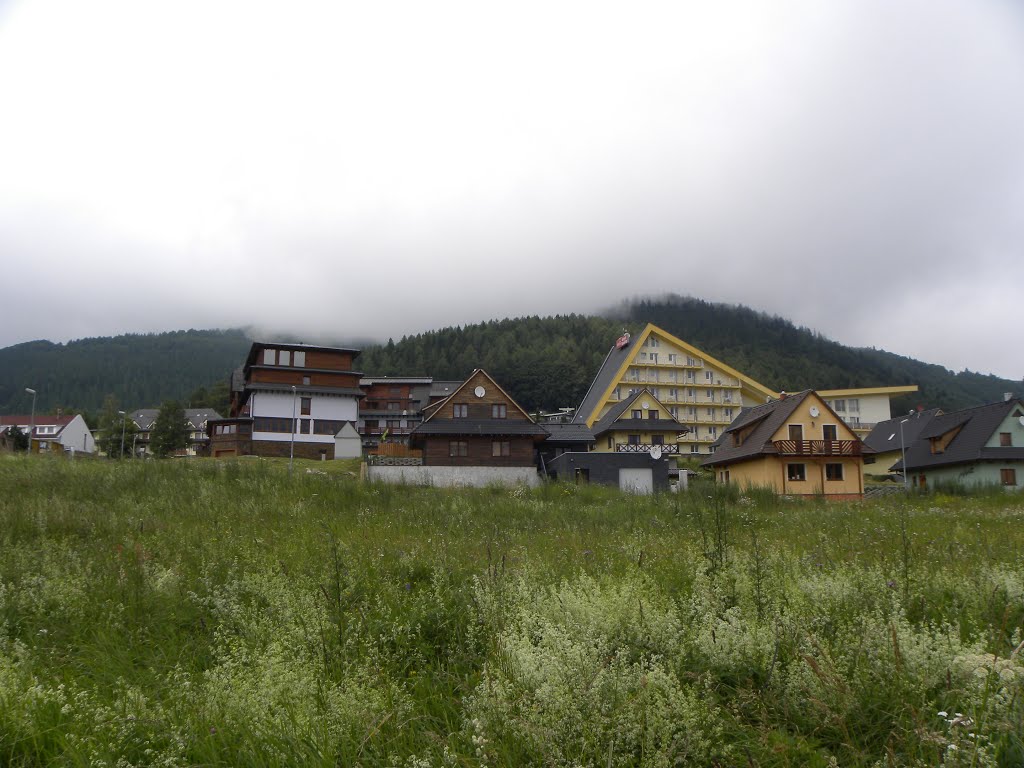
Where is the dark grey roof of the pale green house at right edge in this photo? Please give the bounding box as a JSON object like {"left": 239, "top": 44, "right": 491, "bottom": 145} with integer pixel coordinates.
{"left": 893, "top": 398, "right": 1024, "bottom": 471}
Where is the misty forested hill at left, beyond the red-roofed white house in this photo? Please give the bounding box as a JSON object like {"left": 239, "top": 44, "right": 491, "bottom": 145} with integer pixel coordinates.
{"left": 0, "top": 330, "right": 252, "bottom": 414}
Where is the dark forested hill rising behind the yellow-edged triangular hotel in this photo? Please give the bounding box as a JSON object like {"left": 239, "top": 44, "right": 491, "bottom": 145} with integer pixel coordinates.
{"left": 359, "top": 296, "right": 1022, "bottom": 412}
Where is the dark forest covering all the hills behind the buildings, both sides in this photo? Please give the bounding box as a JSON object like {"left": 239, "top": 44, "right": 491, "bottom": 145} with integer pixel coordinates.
{"left": 0, "top": 296, "right": 1024, "bottom": 421}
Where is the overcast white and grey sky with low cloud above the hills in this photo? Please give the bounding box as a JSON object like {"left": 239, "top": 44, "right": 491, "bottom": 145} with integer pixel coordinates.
{"left": 0, "top": 0, "right": 1024, "bottom": 379}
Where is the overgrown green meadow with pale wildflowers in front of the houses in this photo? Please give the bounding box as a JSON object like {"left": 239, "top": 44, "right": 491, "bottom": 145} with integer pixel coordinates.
{"left": 0, "top": 457, "right": 1024, "bottom": 767}
